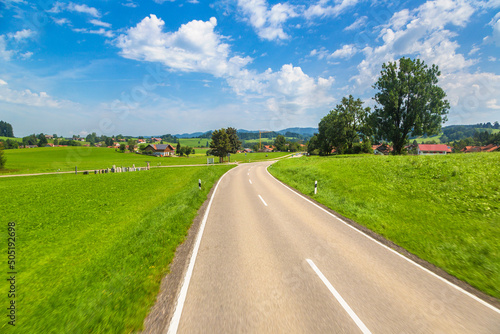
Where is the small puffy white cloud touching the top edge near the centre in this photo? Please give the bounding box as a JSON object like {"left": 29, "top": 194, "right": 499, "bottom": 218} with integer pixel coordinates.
{"left": 238, "top": 0, "right": 298, "bottom": 41}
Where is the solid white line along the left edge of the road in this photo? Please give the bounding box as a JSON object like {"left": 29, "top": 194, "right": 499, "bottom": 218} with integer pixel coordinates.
{"left": 164, "top": 169, "right": 233, "bottom": 334}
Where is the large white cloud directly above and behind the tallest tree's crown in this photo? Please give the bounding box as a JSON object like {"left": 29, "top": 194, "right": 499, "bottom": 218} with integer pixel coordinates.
{"left": 351, "top": 1, "right": 475, "bottom": 89}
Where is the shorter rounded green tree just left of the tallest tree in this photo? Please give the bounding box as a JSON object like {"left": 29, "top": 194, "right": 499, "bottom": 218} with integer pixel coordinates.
{"left": 316, "top": 95, "right": 371, "bottom": 154}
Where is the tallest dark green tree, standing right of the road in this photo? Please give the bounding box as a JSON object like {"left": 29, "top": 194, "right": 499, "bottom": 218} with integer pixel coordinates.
{"left": 372, "top": 58, "right": 450, "bottom": 154}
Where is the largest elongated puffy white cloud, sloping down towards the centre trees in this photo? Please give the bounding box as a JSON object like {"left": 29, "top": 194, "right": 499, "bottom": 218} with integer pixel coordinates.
{"left": 115, "top": 15, "right": 333, "bottom": 117}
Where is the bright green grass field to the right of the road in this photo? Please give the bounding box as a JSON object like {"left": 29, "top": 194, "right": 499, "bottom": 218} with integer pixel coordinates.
{"left": 270, "top": 153, "right": 500, "bottom": 298}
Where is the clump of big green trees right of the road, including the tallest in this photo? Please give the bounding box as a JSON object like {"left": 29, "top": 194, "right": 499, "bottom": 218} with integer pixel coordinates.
{"left": 308, "top": 57, "right": 449, "bottom": 155}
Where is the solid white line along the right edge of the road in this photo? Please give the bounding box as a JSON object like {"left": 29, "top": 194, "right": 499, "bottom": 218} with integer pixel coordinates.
{"left": 266, "top": 166, "right": 500, "bottom": 314}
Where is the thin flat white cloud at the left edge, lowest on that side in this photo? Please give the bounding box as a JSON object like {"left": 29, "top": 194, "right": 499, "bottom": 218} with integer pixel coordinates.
{"left": 0, "top": 80, "right": 73, "bottom": 108}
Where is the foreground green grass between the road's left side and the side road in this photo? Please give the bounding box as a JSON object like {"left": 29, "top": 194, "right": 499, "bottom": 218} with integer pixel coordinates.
{"left": 0, "top": 166, "right": 232, "bottom": 333}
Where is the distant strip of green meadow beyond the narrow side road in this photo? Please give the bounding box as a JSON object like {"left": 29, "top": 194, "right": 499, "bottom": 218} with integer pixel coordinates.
{"left": 0, "top": 147, "right": 292, "bottom": 175}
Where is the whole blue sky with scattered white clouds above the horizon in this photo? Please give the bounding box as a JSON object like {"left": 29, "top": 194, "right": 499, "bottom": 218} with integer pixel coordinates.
{"left": 0, "top": 0, "right": 500, "bottom": 136}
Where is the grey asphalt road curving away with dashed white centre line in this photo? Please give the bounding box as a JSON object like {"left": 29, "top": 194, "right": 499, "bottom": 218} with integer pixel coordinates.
{"left": 165, "top": 162, "right": 500, "bottom": 333}
